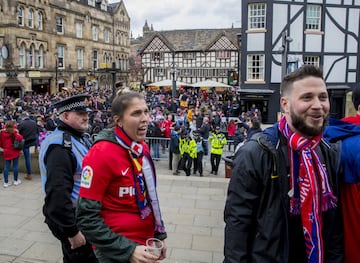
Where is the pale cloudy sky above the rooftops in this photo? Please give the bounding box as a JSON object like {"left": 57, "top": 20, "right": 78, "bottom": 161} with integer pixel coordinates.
{"left": 109, "top": 0, "right": 242, "bottom": 38}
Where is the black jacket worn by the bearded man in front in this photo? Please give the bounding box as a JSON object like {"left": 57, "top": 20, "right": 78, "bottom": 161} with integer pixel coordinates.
{"left": 224, "top": 124, "right": 343, "bottom": 263}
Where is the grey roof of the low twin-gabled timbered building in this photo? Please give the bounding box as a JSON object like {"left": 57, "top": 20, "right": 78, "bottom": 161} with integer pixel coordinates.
{"left": 140, "top": 28, "right": 241, "bottom": 53}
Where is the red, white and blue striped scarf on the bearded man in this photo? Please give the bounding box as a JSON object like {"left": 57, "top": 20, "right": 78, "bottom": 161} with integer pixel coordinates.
{"left": 279, "top": 117, "right": 337, "bottom": 263}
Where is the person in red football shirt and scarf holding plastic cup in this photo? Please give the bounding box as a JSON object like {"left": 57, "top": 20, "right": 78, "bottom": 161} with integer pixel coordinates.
{"left": 77, "top": 91, "right": 167, "bottom": 263}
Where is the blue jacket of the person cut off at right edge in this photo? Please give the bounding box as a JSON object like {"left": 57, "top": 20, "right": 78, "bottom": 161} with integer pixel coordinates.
{"left": 324, "top": 119, "right": 360, "bottom": 184}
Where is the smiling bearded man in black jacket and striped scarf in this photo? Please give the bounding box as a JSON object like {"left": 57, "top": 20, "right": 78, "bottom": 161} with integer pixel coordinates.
{"left": 224, "top": 65, "right": 343, "bottom": 263}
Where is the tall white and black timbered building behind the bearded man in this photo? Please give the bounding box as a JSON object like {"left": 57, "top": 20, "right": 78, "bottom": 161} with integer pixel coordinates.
{"left": 240, "top": 0, "right": 360, "bottom": 123}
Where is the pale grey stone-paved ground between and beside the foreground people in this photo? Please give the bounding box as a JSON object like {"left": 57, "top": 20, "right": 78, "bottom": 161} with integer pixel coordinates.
{"left": 0, "top": 157, "right": 229, "bottom": 263}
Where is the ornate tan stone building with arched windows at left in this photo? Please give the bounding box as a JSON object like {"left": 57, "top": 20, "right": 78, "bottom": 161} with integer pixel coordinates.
{"left": 0, "top": 0, "right": 130, "bottom": 97}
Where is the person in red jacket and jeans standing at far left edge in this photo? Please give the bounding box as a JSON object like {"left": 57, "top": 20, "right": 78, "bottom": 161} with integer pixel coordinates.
{"left": 0, "top": 120, "right": 23, "bottom": 188}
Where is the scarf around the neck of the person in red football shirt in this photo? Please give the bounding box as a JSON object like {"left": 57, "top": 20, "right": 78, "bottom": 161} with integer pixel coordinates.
{"left": 114, "top": 126, "right": 165, "bottom": 233}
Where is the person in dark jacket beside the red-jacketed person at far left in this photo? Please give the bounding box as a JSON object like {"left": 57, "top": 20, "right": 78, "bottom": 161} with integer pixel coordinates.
{"left": 18, "top": 111, "right": 39, "bottom": 180}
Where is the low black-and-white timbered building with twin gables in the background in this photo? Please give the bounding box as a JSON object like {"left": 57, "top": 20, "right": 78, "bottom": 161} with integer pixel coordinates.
{"left": 140, "top": 28, "right": 241, "bottom": 85}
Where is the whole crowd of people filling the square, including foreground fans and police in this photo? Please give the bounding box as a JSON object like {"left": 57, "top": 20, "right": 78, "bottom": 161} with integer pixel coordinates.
{"left": 0, "top": 65, "right": 360, "bottom": 263}
